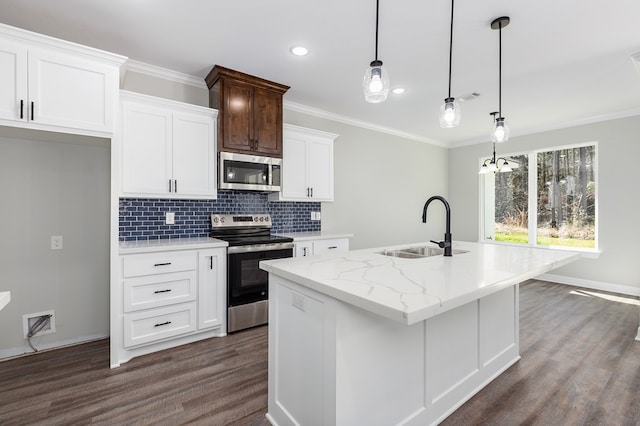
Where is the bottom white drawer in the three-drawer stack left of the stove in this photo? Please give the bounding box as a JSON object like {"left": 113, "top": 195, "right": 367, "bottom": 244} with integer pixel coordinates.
{"left": 124, "top": 302, "right": 197, "bottom": 348}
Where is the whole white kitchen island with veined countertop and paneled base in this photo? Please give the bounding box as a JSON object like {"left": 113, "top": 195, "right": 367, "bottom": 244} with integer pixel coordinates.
{"left": 261, "top": 242, "right": 580, "bottom": 426}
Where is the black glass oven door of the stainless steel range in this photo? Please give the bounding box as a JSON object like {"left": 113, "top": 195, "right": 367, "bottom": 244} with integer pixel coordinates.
{"left": 227, "top": 244, "right": 293, "bottom": 307}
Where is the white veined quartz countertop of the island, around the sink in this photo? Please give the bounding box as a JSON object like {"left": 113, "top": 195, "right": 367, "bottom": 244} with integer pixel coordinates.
{"left": 260, "top": 241, "right": 581, "bottom": 324}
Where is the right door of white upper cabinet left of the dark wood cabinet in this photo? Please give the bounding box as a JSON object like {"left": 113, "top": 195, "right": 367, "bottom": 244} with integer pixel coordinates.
{"left": 173, "top": 113, "right": 216, "bottom": 198}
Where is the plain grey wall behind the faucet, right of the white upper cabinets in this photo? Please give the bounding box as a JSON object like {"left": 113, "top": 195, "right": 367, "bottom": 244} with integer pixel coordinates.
{"left": 284, "top": 110, "right": 456, "bottom": 249}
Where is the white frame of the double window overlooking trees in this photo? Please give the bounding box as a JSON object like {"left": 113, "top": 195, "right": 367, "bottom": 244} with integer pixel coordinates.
{"left": 478, "top": 141, "right": 600, "bottom": 255}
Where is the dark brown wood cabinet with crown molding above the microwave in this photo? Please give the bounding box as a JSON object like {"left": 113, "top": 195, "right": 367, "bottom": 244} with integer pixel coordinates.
{"left": 205, "top": 65, "right": 289, "bottom": 157}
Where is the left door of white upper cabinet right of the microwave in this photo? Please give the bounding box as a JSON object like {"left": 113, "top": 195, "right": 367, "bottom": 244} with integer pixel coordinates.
{"left": 281, "top": 132, "right": 310, "bottom": 200}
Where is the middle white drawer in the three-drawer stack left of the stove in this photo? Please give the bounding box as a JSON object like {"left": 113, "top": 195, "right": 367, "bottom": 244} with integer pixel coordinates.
{"left": 124, "top": 271, "right": 197, "bottom": 312}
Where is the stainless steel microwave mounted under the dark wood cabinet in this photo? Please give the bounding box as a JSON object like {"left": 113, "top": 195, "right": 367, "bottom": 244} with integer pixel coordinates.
{"left": 218, "top": 152, "right": 282, "bottom": 191}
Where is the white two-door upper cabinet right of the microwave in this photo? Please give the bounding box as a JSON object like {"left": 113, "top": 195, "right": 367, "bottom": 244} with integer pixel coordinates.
{"left": 269, "top": 124, "right": 338, "bottom": 201}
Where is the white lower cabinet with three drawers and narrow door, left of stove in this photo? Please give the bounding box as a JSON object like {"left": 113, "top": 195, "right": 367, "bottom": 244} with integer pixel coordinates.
{"left": 111, "top": 247, "right": 227, "bottom": 366}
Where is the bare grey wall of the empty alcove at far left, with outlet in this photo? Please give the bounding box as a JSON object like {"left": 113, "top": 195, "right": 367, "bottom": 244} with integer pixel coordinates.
{"left": 0, "top": 128, "right": 110, "bottom": 358}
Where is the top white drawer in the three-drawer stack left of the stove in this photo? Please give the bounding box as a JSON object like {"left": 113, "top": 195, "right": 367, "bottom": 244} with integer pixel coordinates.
{"left": 122, "top": 251, "right": 198, "bottom": 278}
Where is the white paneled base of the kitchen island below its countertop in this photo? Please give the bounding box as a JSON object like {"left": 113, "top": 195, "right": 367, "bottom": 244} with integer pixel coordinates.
{"left": 267, "top": 273, "right": 519, "bottom": 426}
